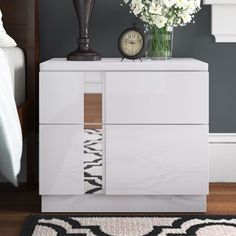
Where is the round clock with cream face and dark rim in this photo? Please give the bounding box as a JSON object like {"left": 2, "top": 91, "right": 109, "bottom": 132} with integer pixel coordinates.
{"left": 119, "top": 29, "right": 144, "bottom": 58}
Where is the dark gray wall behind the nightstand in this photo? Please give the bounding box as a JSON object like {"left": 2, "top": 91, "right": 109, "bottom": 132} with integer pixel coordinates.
{"left": 40, "top": 0, "right": 236, "bottom": 133}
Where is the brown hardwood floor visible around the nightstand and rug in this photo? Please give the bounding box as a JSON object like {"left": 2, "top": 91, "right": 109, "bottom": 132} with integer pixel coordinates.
{"left": 0, "top": 183, "right": 236, "bottom": 236}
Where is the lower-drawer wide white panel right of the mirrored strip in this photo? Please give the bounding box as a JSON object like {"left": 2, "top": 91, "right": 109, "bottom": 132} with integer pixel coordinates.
{"left": 105, "top": 125, "right": 209, "bottom": 195}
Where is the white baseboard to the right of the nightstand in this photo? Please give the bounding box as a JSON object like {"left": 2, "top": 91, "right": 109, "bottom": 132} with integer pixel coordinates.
{"left": 209, "top": 133, "right": 236, "bottom": 183}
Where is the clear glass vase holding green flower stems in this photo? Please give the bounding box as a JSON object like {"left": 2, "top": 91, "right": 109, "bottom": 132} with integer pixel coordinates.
{"left": 146, "top": 27, "right": 173, "bottom": 60}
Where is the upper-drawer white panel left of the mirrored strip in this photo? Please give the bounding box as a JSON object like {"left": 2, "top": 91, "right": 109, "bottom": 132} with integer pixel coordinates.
{"left": 39, "top": 72, "right": 84, "bottom": 124}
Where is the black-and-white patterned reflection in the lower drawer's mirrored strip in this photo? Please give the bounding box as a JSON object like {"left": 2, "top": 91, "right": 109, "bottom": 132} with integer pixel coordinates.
{"left": 84, "top": 129, "right": 102, "bottom": 194}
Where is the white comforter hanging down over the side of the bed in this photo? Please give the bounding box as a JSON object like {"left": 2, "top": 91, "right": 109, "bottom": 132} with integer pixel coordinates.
{"left": 0, "top": 48, "right": 23, "bottom": 185}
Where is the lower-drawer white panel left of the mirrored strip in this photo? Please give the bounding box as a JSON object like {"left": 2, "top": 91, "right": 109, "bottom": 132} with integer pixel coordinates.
{"left": 39, "top": 125, "right": 84, "bottom": 195}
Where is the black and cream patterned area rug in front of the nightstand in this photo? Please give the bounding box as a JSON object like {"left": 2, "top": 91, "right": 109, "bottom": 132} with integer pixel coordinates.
{"left": 20, "top": 216, "right": 236, "bottom": 236}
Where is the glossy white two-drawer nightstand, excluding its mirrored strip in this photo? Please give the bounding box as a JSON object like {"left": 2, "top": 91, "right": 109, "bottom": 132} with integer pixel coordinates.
{"left": 40, "top": 59, "right": 209, "bottom": 212}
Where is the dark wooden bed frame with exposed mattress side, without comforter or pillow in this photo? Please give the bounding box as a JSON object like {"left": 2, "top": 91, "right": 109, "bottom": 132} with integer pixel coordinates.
{"left": 0, "top": 0, "right": 39, "bottom": 188}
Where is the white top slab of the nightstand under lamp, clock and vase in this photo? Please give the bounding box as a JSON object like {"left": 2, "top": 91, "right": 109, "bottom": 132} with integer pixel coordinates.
{"left": 40, "top": 58, "right": 208, "bottom": 71}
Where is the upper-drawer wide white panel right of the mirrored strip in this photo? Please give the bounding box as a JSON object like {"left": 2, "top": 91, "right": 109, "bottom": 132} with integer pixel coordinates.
{"left": 105, "top": 72, "right": 209, "bottom": 124}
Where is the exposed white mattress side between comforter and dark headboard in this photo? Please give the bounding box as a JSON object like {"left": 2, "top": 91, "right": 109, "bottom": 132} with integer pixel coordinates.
{"left": 2, "top": 47, "right": 25, "bottom": 106}
